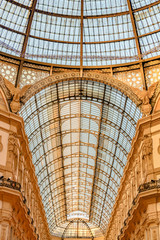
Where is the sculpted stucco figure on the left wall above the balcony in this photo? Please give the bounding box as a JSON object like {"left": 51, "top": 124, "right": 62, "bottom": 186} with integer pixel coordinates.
{"left": 8, "top": 132, "right": 19, "bottom": 171}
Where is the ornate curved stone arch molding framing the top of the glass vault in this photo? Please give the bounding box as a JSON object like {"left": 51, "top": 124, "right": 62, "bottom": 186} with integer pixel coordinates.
{"left": 22, "top": 71, "right": 141, "bottom": 106}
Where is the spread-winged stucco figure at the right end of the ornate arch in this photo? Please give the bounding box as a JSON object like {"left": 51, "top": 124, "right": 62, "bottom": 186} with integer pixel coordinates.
{"left": 131, "top": 82, "right": 158, "bottom": 116}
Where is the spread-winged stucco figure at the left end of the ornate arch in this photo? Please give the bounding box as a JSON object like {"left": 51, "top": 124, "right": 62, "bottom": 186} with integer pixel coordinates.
{"left": 4, "top": 79, "right": 31, "bottom": 113}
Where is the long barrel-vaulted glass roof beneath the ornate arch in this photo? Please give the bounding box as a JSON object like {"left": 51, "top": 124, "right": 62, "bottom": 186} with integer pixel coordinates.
{"left": 20, "top": 80, "right": 142, "bottom": 237}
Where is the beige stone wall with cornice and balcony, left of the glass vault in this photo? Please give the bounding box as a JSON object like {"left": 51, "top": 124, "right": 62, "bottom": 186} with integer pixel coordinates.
{"left": 0, "top": 108, "right": 50, "bottom": 240}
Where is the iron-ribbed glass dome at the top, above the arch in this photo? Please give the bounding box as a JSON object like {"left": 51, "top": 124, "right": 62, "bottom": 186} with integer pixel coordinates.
{"left": 0, "top": 0, "right": 160, "bottom": 67}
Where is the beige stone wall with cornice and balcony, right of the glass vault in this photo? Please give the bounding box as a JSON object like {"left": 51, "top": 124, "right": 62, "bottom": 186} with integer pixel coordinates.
{"left": 106, "top": 111, "right": 160, "bottom": 240}
